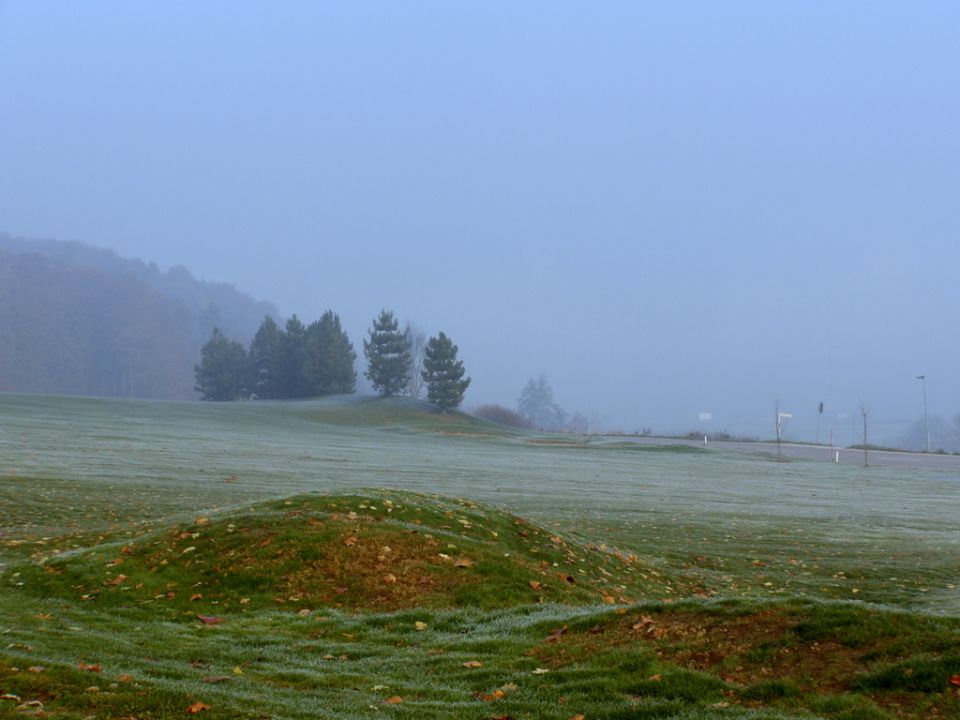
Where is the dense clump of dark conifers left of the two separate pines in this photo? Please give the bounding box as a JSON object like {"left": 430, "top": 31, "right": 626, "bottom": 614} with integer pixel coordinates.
{"left": 195, "top": 310, "right": 357, "bottom": 400}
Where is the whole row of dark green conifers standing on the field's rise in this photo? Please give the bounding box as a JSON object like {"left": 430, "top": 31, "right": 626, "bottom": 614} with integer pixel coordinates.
{"left": 195, "top": 310, "right": 470, "bottom": 411}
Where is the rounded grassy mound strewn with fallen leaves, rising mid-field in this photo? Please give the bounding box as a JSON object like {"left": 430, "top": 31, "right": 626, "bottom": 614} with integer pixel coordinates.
{"left": 17, "top": 492, "right": 663, "bottom": 615}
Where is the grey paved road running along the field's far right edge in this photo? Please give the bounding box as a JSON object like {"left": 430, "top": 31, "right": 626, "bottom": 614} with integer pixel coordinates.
{"left": 617, "top": 437, "right": 960, "bottom": 473}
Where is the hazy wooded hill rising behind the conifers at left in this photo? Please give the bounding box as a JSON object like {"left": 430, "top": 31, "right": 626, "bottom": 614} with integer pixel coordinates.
{"left": 0, "top": 233, "right": 277, "bottom": 399}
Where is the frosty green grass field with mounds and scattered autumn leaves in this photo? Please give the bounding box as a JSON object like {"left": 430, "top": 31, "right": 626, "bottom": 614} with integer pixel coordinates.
{"left": 0, "top": 395, "right": 960, "bottom": 720}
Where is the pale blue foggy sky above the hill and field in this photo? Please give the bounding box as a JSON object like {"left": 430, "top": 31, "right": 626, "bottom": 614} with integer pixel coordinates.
{"left": 0, "top": 0, "right": 960, "bottom": 442}
